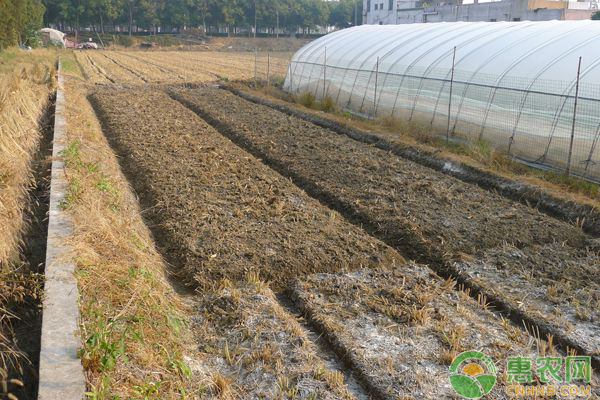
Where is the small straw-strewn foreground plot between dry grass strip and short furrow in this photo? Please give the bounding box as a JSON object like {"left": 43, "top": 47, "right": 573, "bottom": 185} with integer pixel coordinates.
{"left": 191, "top": 278, "right": 354, "bottom": 400}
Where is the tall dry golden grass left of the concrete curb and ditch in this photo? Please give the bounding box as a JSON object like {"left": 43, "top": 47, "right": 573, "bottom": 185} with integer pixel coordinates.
{"left": 0, "top": 50, "right": 54, "bottom": 395}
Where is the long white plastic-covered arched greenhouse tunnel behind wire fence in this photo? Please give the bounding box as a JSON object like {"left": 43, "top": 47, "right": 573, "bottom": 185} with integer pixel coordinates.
{"left": 284, "top": 21, "right": 600, "bottom": 180}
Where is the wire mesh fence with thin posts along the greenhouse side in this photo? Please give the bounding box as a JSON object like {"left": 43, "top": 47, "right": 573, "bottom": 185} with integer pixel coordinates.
{"left": 284, "top": 56, "right": 600, "bottom": 181}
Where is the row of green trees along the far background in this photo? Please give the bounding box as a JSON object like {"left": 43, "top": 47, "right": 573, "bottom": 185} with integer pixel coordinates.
{"left": 43, "top": 0, "right": 362, "bottom": 34}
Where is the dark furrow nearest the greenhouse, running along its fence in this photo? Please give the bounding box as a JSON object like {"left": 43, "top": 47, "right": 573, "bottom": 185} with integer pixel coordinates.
{"left": 221, "top": 85, "right": 600, "bottom": 237}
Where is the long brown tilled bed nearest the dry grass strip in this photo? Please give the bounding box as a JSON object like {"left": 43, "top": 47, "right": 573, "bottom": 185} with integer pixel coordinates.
{"left": 92, "top": 88, "right": 402, "bottom": 288}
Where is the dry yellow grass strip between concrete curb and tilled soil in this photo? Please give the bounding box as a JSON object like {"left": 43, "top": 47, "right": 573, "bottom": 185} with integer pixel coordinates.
{"left": 58, "top": 62, "right": 196, "bottom": 399}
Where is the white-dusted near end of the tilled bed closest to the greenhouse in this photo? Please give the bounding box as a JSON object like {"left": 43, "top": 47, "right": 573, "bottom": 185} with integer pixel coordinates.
{"left": 454, "top": 243, "right": 600, "bottom": 356}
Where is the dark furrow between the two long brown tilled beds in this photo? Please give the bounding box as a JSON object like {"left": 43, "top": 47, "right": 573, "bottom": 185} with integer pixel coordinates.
{"left": 170, "top": 91, "right": 600, "bottom": 368}
